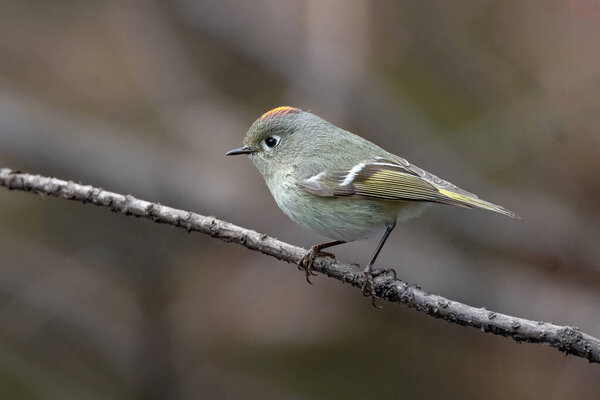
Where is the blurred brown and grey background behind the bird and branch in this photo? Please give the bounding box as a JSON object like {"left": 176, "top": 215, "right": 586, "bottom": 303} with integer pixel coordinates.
{"left": 0, "top": 0, "right": 600, "bottom": 400}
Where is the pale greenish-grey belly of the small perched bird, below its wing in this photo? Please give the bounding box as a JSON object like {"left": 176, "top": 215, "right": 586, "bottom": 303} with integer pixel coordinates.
{"left": 268, "top": 177, "right": 423, "bottom": 242}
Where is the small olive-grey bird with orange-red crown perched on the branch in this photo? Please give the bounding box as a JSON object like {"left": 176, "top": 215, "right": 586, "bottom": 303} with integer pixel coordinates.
{"left": 227, "top": 106, "right": 517, "bottom": 305}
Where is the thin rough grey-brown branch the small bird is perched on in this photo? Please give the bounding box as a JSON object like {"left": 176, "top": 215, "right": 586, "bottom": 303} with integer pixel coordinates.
{"left": 0, "top": 168, "right": 600, "bottom": 363}
